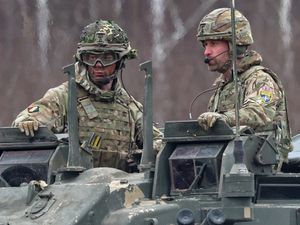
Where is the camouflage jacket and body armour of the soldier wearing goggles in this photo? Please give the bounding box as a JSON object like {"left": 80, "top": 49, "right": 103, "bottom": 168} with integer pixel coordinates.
{"left": 13, "top": 64, "right": 162, "bottom": 171}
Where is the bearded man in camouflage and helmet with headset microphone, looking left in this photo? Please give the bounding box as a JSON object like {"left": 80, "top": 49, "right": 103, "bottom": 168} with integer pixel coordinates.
{"left": 197, "top": 8, "right": 292, "bottom": 161}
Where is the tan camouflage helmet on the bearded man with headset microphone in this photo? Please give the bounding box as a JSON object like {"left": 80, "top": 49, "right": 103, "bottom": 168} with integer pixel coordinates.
{"left": 197, "top": 8, "right": 253, "bottom": 46}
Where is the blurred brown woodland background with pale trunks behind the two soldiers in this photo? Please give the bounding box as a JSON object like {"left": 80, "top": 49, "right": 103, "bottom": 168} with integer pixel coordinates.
{"left": 0, "top": 0, "right": 300, "bottom": 134}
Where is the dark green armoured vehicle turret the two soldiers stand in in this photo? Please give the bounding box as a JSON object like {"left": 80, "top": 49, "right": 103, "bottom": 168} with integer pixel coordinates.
{"left": 0, "top": 59, "right": 300, "bottom": 225}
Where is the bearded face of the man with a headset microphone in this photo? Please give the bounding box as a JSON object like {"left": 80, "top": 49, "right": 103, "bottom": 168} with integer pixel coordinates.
{"left": 203, "top": 40, "right": 230, "bottom": 72}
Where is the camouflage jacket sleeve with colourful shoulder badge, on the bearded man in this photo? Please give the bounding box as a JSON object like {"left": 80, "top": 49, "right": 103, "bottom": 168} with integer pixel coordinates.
{"left": 224, "top": 71, "right": 283, "bottom": 129}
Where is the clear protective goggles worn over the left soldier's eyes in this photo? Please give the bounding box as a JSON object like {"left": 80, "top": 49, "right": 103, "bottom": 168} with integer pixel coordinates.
{"left": 81, "top": 51, "right": 120, "bottom": 66}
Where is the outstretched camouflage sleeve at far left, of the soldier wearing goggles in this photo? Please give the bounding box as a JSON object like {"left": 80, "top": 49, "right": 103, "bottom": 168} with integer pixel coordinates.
{"left": 12, "top": 83, "right": 68, "bottom": 133}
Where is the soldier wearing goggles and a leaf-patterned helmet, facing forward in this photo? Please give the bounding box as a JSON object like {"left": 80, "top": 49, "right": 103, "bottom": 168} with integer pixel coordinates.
{"left": 13, "top": 20, "right": 161, "bottom": 171}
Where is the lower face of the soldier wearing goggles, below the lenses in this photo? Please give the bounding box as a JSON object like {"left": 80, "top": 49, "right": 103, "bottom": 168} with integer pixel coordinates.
{"left": 88, "top": 62, "right": 116, "bottom": 84}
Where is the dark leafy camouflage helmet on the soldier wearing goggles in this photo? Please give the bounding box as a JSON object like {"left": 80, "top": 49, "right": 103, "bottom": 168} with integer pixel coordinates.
{"left": 76, "top": 20, "right": 137, "bottom": 62}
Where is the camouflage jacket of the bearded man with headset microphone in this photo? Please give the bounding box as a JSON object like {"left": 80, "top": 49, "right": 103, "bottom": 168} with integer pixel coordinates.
{"left": 208, "top": 51, "right": 292, "bottom": 161}
